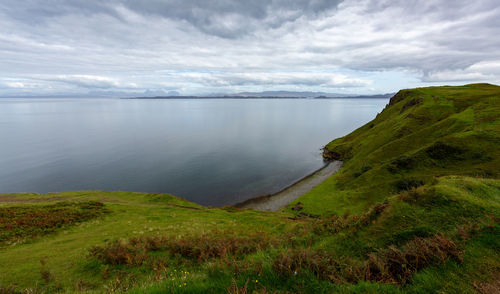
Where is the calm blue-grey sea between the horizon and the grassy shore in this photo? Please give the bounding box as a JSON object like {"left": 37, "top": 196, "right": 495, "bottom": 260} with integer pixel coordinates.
{"left": 0, "top": 99, "right": 388, "bottom": 206}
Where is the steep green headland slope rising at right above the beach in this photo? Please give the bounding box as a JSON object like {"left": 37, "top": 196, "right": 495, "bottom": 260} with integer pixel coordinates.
{"left": 296, "top": 84, "right": 500, "bottom": 215}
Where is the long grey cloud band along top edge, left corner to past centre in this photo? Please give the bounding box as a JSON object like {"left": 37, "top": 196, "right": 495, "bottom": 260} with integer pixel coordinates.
{"left": 0, "top": 0, "right": 342, "bottom": 38}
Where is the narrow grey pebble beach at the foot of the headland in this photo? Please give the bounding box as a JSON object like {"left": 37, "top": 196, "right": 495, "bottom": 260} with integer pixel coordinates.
{"left": 234, "top": 161, "right": 342, "bottom": 211}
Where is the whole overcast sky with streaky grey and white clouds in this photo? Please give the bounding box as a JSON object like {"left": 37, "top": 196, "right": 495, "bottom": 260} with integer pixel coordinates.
{"left": 0, "top": 0, "right": 500, "bottom": 97}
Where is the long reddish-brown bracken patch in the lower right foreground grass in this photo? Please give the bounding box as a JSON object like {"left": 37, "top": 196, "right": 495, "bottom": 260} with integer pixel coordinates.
{"left": 273, "top": 235, "right": 462, "bottom": 284}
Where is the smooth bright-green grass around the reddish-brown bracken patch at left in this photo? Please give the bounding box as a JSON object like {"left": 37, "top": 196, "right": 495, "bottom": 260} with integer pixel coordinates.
{"left": 0, "top": 191, "right": 293, "bottom": 288}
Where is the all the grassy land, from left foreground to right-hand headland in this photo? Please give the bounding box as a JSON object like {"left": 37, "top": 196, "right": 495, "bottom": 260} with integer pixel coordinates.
{"left": 0, "top": 84, "right": 500, "bottom": 293}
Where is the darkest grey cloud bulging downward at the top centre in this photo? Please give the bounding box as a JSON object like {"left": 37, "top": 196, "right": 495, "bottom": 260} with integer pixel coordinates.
{"left": 125, "top": 0, "right": 341, "bottom": 38}
